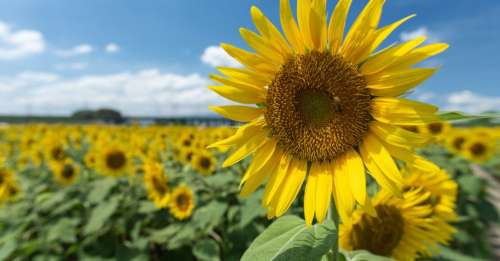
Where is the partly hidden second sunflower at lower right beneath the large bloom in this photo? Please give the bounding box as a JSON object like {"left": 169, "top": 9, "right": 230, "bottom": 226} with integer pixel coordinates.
{"left": 339, "top": 187, "right": 444, "bottom": 261}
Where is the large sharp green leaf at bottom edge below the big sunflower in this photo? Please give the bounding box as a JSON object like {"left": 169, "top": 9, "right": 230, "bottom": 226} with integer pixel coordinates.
{"left": 241, "top": 216, "right": 337, "bottom": 261}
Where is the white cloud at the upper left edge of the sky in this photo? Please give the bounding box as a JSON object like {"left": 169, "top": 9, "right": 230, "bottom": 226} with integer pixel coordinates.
{"left": 0, "top": 21, "right": 45, "bottom": 60}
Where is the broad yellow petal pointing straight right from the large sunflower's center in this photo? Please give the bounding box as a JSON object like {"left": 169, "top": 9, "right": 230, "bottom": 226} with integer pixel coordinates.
{"left": 371, "top": 97, "right": 438, "bottom": 126}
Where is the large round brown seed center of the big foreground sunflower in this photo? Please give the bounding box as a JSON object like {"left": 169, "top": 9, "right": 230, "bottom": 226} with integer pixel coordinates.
{"left": 265, "top": 51, "right": 372, "bottom": 161}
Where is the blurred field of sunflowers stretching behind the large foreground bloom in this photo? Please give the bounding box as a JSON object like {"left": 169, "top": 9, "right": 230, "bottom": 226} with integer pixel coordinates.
{"left": 0, "top": 123, "right": 500, "bottom": 260}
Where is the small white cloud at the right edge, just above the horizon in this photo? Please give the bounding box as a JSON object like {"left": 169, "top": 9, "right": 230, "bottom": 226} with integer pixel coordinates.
{"left": 444, "top": 90, "right": 500, "bottom": 113}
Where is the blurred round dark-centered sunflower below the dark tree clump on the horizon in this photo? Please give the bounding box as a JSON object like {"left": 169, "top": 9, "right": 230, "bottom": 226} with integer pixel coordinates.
{"left": 96, "top": 143, "right": 132, "bottom": 177}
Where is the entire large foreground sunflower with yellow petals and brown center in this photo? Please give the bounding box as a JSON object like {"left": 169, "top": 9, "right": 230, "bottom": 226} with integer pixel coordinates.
{"left": 209, "top": 0, "right": 448, "bottom": 224}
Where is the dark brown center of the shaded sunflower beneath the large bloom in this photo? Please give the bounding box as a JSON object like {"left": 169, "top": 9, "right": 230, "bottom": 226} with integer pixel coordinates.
{"left": 351, "top": 205, "right": 404, "bottom": 256}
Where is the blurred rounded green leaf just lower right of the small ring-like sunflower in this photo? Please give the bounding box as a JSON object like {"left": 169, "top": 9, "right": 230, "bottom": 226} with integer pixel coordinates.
{"left": 192, "top": 201, "right": 227, "bottom": 231}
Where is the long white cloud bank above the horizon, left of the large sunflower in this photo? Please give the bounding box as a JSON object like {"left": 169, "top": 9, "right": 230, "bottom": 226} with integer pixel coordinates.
{"left": 0, "top": 69, "right": 225, "bottom": 116}
